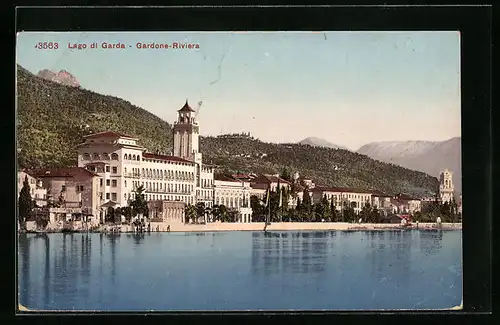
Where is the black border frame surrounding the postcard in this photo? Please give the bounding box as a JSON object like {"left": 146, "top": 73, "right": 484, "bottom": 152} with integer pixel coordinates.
{"left": 4, "top": 6, "right": 493, "bottom": 322}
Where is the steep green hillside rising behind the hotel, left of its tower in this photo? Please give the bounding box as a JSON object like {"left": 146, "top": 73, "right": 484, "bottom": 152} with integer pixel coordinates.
{"left": 17, "top": 66, "right": 171, "bottom": 167}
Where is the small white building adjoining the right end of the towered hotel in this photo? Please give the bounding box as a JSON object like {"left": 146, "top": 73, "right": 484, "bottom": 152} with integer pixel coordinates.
{"left": 214, "top": 175, "right": 252, "bottom": 222}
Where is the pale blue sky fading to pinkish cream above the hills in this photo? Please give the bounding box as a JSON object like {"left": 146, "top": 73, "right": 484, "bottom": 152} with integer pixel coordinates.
{"left": 16, "top": 31, "right": 461, "bottom": 150}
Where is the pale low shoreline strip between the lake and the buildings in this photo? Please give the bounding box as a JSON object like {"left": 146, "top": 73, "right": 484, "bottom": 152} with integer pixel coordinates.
{"left": 21, "top": 222, "right": 462, "bottom": 234}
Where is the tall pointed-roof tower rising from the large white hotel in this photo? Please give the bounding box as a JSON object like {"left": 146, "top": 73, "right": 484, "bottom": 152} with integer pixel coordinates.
{"left": 172, "top": 100, "right": 201, "bottom": 164}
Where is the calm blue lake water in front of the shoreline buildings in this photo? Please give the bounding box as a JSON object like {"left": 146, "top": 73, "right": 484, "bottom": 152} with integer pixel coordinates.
{"left": 18, "top": 230, "right": 462, "bottom": 311}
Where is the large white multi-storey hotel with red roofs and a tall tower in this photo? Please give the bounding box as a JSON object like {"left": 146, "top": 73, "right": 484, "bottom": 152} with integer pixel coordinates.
{"left": 78, "top": 101, "right": 214, "bottom": 214}
